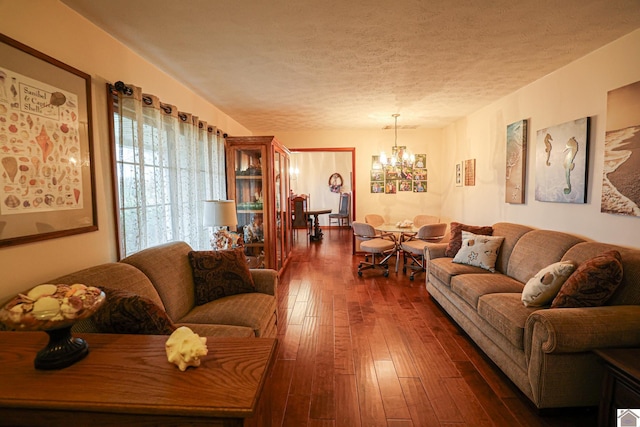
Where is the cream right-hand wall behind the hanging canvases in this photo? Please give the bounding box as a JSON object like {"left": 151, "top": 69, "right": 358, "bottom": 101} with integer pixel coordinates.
{"left": 442, "top": 30, "right": 640, "bottom": 247}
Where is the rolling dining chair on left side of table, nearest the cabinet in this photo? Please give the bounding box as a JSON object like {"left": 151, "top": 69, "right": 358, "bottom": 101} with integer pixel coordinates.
{"left": 351, "top": 221, "right": 398, "bottom": 277}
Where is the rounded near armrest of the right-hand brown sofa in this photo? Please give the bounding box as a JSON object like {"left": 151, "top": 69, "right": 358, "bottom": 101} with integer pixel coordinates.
{"left": 525, "top": 305, "right": 640, "bottom": 359}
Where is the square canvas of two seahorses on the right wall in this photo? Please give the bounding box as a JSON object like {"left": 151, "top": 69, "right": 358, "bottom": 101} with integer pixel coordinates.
{"left": 536, "top": 117, "right": 589, "bottom": 203}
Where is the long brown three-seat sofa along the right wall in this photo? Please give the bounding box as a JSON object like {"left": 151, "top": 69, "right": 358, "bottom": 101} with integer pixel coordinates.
{"left": 425, "top": 222, "right": 640, "bottom": 408}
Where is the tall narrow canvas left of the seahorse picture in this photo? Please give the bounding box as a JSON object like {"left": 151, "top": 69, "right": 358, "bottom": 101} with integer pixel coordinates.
{"left": 505, "top": 120, "right": 527, "bottom": 204}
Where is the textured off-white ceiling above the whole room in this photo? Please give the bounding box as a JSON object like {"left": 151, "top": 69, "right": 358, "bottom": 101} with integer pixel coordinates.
{"left": 62, "top": 0, "right": 640, "bottom": 131}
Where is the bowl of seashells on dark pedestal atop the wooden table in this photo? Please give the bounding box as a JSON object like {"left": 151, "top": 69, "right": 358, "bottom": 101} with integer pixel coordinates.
{"left": 0, "top": 283, "right": 105, "bottom": 369}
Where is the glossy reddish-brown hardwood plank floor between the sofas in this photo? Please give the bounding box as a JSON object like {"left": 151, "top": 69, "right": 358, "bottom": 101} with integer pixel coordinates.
{"left": 248, "top": 228, "right": 597, "bottom": 427}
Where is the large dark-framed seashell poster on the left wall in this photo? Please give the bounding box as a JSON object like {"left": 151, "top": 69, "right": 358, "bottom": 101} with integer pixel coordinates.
{"left": 0, "top": 34, "right": 98, "bottom": 247}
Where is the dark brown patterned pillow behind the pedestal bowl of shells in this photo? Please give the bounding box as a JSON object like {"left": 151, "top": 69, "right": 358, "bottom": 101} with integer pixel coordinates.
{"left": 91, "top": 287, "right": 176, "bottom": 335}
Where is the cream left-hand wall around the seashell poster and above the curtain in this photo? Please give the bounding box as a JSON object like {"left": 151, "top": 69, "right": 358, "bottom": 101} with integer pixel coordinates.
{"left": 0, "top": 0, "right": 250, "bottom": 301}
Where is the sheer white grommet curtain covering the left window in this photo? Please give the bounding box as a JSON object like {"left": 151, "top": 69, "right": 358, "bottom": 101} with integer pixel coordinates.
{"left": 112, "top": 85, "right": 226, "bottom": 257}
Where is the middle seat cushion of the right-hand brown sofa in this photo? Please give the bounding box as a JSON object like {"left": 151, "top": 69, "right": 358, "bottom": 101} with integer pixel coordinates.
{"left": 451, "top": 270, "right": 522, "bottom": 310}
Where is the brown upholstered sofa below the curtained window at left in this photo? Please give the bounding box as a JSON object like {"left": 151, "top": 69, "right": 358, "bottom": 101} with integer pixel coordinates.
{"left": 37, "top": 242, "right": 278, "bottom": 337}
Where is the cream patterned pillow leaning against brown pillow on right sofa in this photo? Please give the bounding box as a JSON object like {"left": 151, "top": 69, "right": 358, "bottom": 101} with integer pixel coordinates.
{"left": 521, "top": 261, "right": 576, "bottom": 307}
